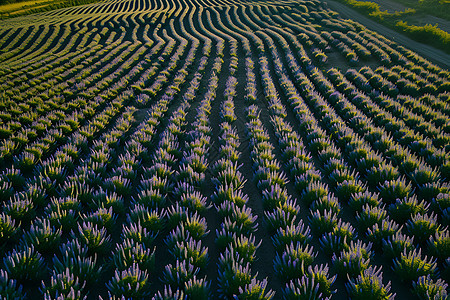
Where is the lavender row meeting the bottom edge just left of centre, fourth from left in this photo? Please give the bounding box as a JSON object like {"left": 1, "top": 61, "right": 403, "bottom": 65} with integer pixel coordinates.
{"left": 151, "top": 11, "right": 214, "bottom": 299}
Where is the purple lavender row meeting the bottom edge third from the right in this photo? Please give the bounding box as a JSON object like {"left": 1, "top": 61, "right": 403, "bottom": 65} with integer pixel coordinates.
{"left": 246, "top": 52, "right": 334, "bottom": 299}
